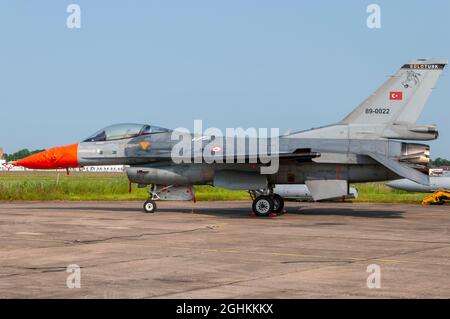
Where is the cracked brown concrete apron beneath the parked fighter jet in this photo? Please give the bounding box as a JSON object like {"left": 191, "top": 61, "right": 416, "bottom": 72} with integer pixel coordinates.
{"left": 0, "top": 202, "right": 450, "bottom": 298}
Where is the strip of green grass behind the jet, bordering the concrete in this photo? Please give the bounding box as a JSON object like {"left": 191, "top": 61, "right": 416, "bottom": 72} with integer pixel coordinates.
{"left": 0, "top": 172, "right": 426, "bottom": 203}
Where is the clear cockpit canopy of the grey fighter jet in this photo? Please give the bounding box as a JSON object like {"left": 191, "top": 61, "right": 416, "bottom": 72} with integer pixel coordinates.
{"left": 83, "top": 123, "right": 169, "bottom": 142}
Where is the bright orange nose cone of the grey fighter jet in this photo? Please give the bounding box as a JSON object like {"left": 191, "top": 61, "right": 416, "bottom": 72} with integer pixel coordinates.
{"left": 13, "top": 144, "right": 78, "bottom": 169}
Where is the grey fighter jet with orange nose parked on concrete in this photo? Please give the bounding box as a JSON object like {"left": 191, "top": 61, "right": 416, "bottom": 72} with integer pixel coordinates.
{"left": 14, "top": 59, "right": 448, "bottom": 216}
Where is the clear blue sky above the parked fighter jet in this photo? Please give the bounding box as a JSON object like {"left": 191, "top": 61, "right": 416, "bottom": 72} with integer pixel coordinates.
{"left": 0, "top": 0, "right": 450, "bottom": 158}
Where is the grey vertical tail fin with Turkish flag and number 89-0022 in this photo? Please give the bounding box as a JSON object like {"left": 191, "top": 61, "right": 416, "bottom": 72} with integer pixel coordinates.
{"left": 341, "top": 59, "right": 448, "bottom": 125}
